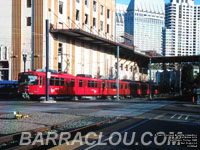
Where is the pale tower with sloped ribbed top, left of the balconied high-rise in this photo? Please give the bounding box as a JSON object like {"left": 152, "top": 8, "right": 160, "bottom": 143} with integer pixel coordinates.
{"left": 125, "top": 0, "right": 165, "bottom": 54}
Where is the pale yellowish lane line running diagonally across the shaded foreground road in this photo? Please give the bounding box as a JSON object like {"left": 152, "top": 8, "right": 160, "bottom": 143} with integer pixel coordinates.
{"left": 85, "top": 119, "right": 151, "bottom": 150}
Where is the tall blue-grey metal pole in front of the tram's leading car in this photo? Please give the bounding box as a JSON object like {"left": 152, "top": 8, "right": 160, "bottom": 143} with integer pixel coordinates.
{"left": 46, "top": 19, "right": 51, "bottom": 101}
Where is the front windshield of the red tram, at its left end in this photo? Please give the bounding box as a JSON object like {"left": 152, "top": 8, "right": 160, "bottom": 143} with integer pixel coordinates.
{"left": 19, "top": 75, "right": 38, "bottom": 85}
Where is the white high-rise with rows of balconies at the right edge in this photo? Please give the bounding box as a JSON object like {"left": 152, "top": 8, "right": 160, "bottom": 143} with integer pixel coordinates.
{"left": 163, "top": 0, "right": 200, "bottom": 56}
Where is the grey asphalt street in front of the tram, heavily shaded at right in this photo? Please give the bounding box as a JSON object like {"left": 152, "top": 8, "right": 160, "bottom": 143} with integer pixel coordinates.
{"left": 0, "top": 100, "right": 200, "bottom": 150}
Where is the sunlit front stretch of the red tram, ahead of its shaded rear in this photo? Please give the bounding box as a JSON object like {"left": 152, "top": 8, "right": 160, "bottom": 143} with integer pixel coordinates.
{"left": 18, "top": 70, "right": 130, "bottom": 98}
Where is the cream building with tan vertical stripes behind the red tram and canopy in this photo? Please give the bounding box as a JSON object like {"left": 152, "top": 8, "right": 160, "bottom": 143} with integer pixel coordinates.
{"left": 12, "top": 0, "right": 147, "bottom": 80}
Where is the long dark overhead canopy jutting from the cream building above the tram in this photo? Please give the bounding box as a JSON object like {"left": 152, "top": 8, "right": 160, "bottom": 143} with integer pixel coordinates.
{"left": 50, "top": 29, "right": 200, "bottom": 68}
